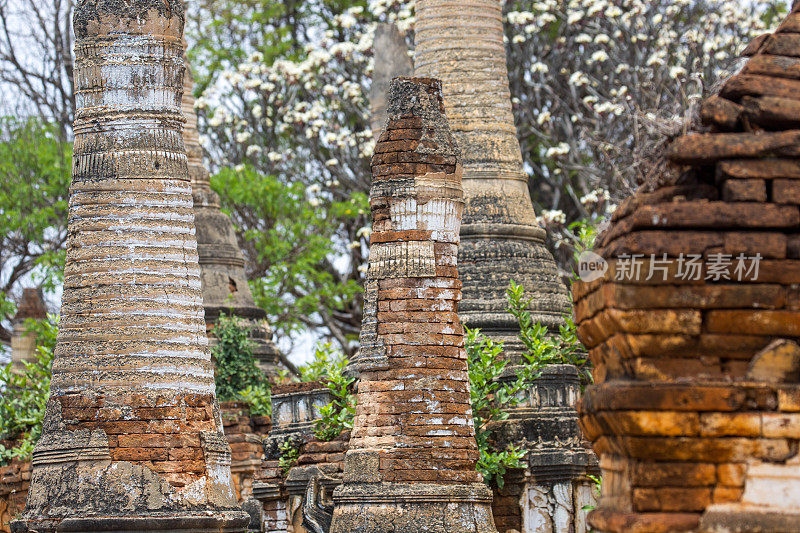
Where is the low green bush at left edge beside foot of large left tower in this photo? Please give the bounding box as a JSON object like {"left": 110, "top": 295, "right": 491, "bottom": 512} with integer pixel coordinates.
{"left": 0, "top": 317, "right": 58, "bottom": 466}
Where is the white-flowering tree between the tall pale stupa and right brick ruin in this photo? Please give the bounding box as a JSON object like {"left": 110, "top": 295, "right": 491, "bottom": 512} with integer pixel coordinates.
{"left": 505, "top": 0, "right": 786, "bottom": 266}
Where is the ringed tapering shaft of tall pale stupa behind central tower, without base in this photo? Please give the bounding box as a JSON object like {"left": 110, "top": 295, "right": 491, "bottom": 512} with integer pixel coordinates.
{"left": 415, "top": 0, "right": 570, "bottom": 360}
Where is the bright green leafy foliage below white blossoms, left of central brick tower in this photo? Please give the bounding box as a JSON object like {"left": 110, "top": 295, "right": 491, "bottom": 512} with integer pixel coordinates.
{"left": 212, "top": 166, "right": 368, "bottom": 347}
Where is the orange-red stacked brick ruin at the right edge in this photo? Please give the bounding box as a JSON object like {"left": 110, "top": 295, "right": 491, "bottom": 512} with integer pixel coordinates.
{"left": 574, "top": 7, "right": 800, "bottom": 533}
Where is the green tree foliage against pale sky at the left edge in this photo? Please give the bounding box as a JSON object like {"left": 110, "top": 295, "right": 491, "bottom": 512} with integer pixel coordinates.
{"left": 0, "top": 118, "right": 72, "bottom": 333}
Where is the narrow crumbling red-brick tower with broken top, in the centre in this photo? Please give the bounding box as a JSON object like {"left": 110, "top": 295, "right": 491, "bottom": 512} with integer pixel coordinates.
{"left": 331, "top": 78, "right": 496, "bottom": 533}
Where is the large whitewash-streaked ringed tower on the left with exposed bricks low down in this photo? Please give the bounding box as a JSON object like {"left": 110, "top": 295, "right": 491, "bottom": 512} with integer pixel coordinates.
{"left": 13, "top": 0, "right": 249, "bottom": 533}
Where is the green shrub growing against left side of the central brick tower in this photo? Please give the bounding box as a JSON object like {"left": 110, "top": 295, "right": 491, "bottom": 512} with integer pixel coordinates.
{"left": 300, "top": 344, "right": 356, "bottom": 441}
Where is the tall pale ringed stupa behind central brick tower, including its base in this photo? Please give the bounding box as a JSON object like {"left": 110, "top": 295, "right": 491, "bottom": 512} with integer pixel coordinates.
{"left": 415, "top": 0, "right": 596, "bottom": 532}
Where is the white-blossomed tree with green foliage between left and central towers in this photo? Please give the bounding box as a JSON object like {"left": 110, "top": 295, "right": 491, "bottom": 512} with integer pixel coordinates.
{"left": 189, "top": 0, "right": 412, "bottom": 354}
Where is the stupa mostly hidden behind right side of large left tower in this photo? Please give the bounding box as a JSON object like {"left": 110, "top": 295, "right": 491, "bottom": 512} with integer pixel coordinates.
{"left": 182, "top": 50, "right": 297, "bottom": 377}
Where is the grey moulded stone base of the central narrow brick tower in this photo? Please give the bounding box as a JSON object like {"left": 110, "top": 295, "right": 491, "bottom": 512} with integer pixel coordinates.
{"left": 330, "top": 482, "right": 497, "bottom": 533}
